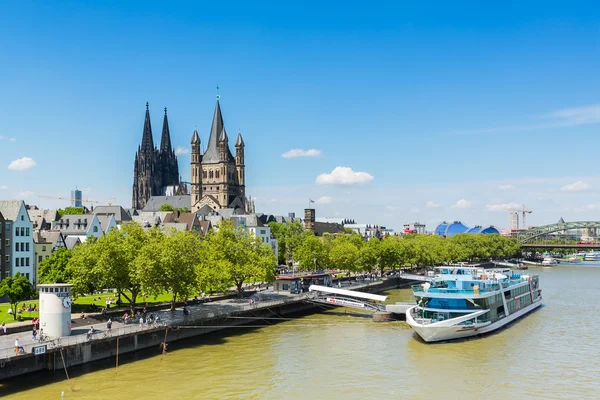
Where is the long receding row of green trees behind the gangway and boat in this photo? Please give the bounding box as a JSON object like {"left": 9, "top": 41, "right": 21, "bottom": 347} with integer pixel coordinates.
{"left": 269, "top": 222, "right": 520, "bottom": 272}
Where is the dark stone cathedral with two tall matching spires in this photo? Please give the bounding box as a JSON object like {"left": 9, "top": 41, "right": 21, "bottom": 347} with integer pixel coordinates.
{"left": 132, "top": 103, "right": 180, "bottom": 210}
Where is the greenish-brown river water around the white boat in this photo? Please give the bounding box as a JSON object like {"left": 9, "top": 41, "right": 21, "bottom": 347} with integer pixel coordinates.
{"left": 0, "top": 263, "right": 600, "bottom": 400}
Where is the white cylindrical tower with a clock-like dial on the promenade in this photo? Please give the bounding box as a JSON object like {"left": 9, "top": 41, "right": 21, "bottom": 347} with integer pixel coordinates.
{"left": 38, "top": 283, "right": 73, "bottom": 337}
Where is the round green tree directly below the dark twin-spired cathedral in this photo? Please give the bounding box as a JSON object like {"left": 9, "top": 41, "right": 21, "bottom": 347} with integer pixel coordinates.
{"left": 135, "top": 231, "right": 200, "bottom": 311}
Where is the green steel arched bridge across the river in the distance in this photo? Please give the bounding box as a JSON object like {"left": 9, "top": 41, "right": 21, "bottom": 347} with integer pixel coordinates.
{"left": 513, "top": 221, "right": 600, "bottom": 249}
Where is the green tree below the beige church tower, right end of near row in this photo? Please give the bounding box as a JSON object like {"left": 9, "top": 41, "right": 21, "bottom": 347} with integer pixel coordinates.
{"left": 200, "top": 221, "right": 277, "bottom": 295}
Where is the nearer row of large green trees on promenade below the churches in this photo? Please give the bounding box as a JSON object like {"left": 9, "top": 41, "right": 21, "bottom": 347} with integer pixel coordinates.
{"left": 39, "top": 222, "right": 277, "bottom": 311}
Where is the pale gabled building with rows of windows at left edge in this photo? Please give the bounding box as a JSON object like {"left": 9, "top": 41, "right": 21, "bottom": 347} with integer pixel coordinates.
{"left": 0, "top": 200, "right": 36, "bottom": 285}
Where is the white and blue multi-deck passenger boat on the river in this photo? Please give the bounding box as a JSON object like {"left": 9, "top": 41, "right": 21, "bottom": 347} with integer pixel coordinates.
{"left": 406, "top": 267, "right": 542, "bottom": 342}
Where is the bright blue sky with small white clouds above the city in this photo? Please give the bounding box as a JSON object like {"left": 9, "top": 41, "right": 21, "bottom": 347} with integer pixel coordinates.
{"left": 0, "top": 0, "right": 600, "bottom": 230}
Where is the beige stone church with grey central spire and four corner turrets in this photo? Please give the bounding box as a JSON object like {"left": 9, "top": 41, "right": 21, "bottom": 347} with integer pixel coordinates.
{"left": 191, "top": 99, "right": 254, "bottom": 213}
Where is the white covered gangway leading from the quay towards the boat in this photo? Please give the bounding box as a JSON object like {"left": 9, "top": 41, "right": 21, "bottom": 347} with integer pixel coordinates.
{"left": 308, "top": 285, "right": 387, "bottom": 312}
